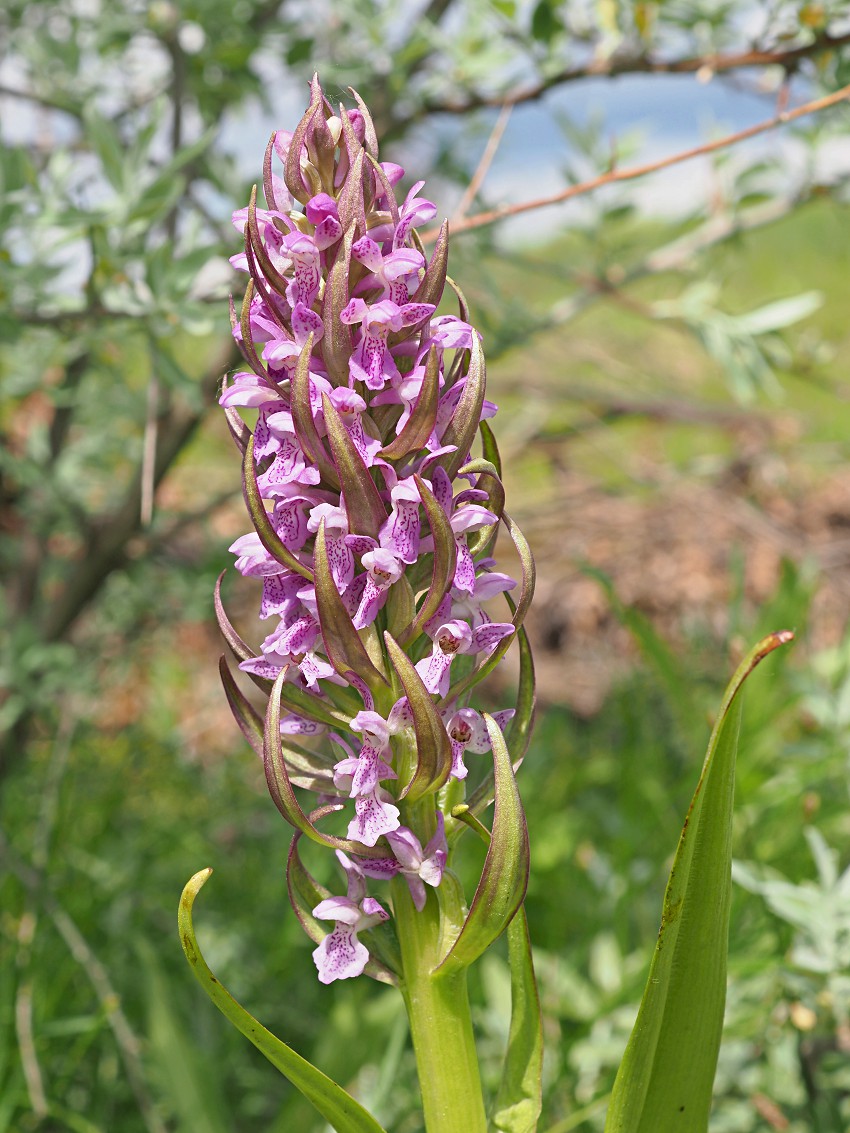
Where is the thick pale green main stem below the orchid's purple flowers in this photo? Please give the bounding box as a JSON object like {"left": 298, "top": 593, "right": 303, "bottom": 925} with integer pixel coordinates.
{"left": 393, "top": 878, "right": 487, "bottom": 1133}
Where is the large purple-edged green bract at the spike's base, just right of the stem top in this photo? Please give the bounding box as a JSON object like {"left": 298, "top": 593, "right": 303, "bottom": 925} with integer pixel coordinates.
{"left": 436, "top": 713, "right": 528, "bottom": 972}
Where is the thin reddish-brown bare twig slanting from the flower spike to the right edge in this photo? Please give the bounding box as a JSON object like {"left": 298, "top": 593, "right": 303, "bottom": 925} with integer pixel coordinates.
{"left": 422, "top": 85, "right": 850, "bottom": 244}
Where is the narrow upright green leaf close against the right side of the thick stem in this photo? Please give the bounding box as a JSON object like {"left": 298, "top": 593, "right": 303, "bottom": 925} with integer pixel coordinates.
{"left": 491, "top": 909, "right": 543, "bottom": 1133}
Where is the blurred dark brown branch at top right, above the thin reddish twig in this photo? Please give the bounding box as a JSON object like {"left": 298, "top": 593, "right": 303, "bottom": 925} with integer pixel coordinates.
{"left": 423, "top": 32, "right": 850, "bottom": 114}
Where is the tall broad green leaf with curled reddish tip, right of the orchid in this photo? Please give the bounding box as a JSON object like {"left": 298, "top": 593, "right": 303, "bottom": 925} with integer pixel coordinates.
{"left": 605, "top": 631, "right": 793, "bottom": 1133}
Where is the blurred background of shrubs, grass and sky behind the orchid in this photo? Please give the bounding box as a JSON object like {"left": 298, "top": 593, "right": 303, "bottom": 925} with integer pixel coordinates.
{"left": 0, "top": 0, "right": 850, "bottom": 1133}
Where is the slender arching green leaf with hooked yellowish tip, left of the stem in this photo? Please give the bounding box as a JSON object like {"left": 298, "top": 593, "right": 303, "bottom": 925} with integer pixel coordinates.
{"left": 178, "top": 869, "right": 392, "bottom": 1133}
